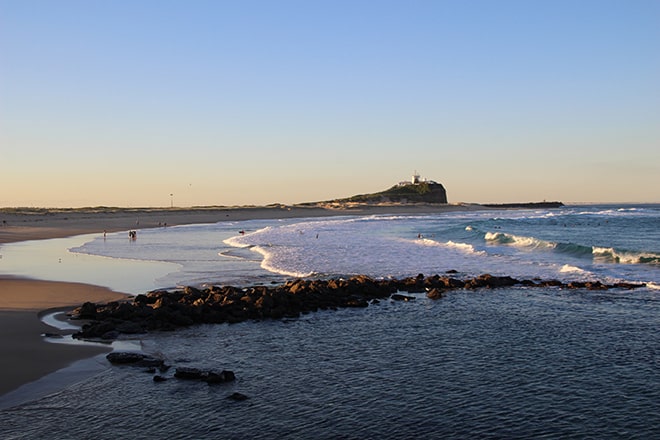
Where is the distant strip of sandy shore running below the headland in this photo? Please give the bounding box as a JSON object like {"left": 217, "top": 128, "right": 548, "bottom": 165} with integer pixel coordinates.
{"left": 0, "top": 202, "right": 563, "bottom": 244}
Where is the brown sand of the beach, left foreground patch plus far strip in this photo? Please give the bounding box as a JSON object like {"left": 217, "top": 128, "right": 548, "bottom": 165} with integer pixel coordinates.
{"left": 0, "top": 204, "right": 476, "bottom": 395}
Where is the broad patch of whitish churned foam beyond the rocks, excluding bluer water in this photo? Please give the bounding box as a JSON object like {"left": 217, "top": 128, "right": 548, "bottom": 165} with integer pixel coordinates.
{"left": 217, "top": 213, "right": 660, "bottom": 286}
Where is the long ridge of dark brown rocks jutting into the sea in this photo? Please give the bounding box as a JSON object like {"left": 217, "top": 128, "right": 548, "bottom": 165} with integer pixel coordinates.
{"left": 71, "top": 274, "right": 644, "bottom": 339}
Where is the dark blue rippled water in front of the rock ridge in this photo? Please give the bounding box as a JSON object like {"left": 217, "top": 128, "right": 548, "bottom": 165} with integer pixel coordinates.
{"left": 0, "top": 289, "right": 660, "bottom": 439}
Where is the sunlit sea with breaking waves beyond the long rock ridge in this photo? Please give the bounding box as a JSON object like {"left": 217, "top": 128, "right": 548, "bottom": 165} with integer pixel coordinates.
{"left": 63, "top": 205, "right": 660, "bottom": 288}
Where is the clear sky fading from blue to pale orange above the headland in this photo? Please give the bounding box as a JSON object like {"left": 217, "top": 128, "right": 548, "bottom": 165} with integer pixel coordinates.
{"left": 0, "top": 0, "right": 660, "bottom": 207}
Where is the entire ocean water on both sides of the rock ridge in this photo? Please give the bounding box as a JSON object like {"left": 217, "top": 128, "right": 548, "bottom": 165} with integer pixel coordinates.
{"left": 0, "top": 205, "right": 660, "bottom": 439}
